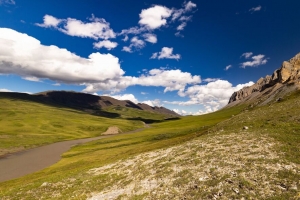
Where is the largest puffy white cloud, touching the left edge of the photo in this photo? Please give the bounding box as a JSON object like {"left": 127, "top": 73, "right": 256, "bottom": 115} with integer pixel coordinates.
{"left": 0, "top": 28, "right": 124, "bottom": 84}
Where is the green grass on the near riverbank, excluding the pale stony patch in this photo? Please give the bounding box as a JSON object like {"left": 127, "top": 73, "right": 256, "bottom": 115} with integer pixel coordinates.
{"left": 0, "top": 92, "right": 300, "bottom": 199}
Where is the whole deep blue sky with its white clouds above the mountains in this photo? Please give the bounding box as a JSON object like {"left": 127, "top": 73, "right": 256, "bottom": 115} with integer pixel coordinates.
{"left": 0, "top": 0, "right": 300, "bottom": 114}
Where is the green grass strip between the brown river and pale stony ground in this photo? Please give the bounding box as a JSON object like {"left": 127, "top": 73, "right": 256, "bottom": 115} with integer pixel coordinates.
{"left": 0, "top": 102, "right": 242, "bottom": 199}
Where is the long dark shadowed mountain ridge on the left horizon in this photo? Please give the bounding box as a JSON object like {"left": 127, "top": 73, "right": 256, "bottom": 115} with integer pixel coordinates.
{"left": 0, "top": 91, "right": 180, "bottom": 118}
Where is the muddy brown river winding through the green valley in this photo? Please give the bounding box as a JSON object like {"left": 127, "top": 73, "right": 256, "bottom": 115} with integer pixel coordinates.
{"left": 0, "top": 125, "right": 149, "bottom": 182}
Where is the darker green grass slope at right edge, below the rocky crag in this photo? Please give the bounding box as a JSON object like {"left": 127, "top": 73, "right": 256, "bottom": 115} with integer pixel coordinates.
{"left": 213, "top": 91, "right": 300, "bottom": 164}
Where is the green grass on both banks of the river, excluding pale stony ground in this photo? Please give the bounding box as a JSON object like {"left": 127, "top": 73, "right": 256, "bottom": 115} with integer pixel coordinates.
{"left": 0, "top": 93, "right": 300, "bottom": 199}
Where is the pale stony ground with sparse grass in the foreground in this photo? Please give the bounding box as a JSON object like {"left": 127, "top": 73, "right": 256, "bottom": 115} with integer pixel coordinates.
{"left": 17, "top": 130, "right": 300, "bottom": 200}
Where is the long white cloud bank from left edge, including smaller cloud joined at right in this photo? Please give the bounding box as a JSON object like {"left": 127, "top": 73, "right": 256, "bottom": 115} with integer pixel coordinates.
{"left": 0, "top": 28, "right": 201, "bottom": 96}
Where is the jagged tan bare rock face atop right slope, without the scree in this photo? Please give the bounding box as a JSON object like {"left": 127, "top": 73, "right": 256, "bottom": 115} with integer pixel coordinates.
{"left": 228, "top": 53, "right": 300, "bottom": 104}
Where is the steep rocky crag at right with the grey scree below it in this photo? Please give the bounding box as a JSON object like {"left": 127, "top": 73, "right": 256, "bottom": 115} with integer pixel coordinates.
{"left": 228, "top": 53, "right": 300, "bottom": 106}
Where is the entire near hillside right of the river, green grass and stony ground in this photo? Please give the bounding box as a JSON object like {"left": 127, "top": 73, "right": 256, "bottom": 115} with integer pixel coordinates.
{"left": 0, "top": 92, "right": 300, "bottom": 199}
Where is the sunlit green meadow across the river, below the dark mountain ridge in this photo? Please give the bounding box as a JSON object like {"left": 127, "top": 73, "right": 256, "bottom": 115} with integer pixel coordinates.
{"left": 0, "top": 96, "right": 146, "bottom": 155}
